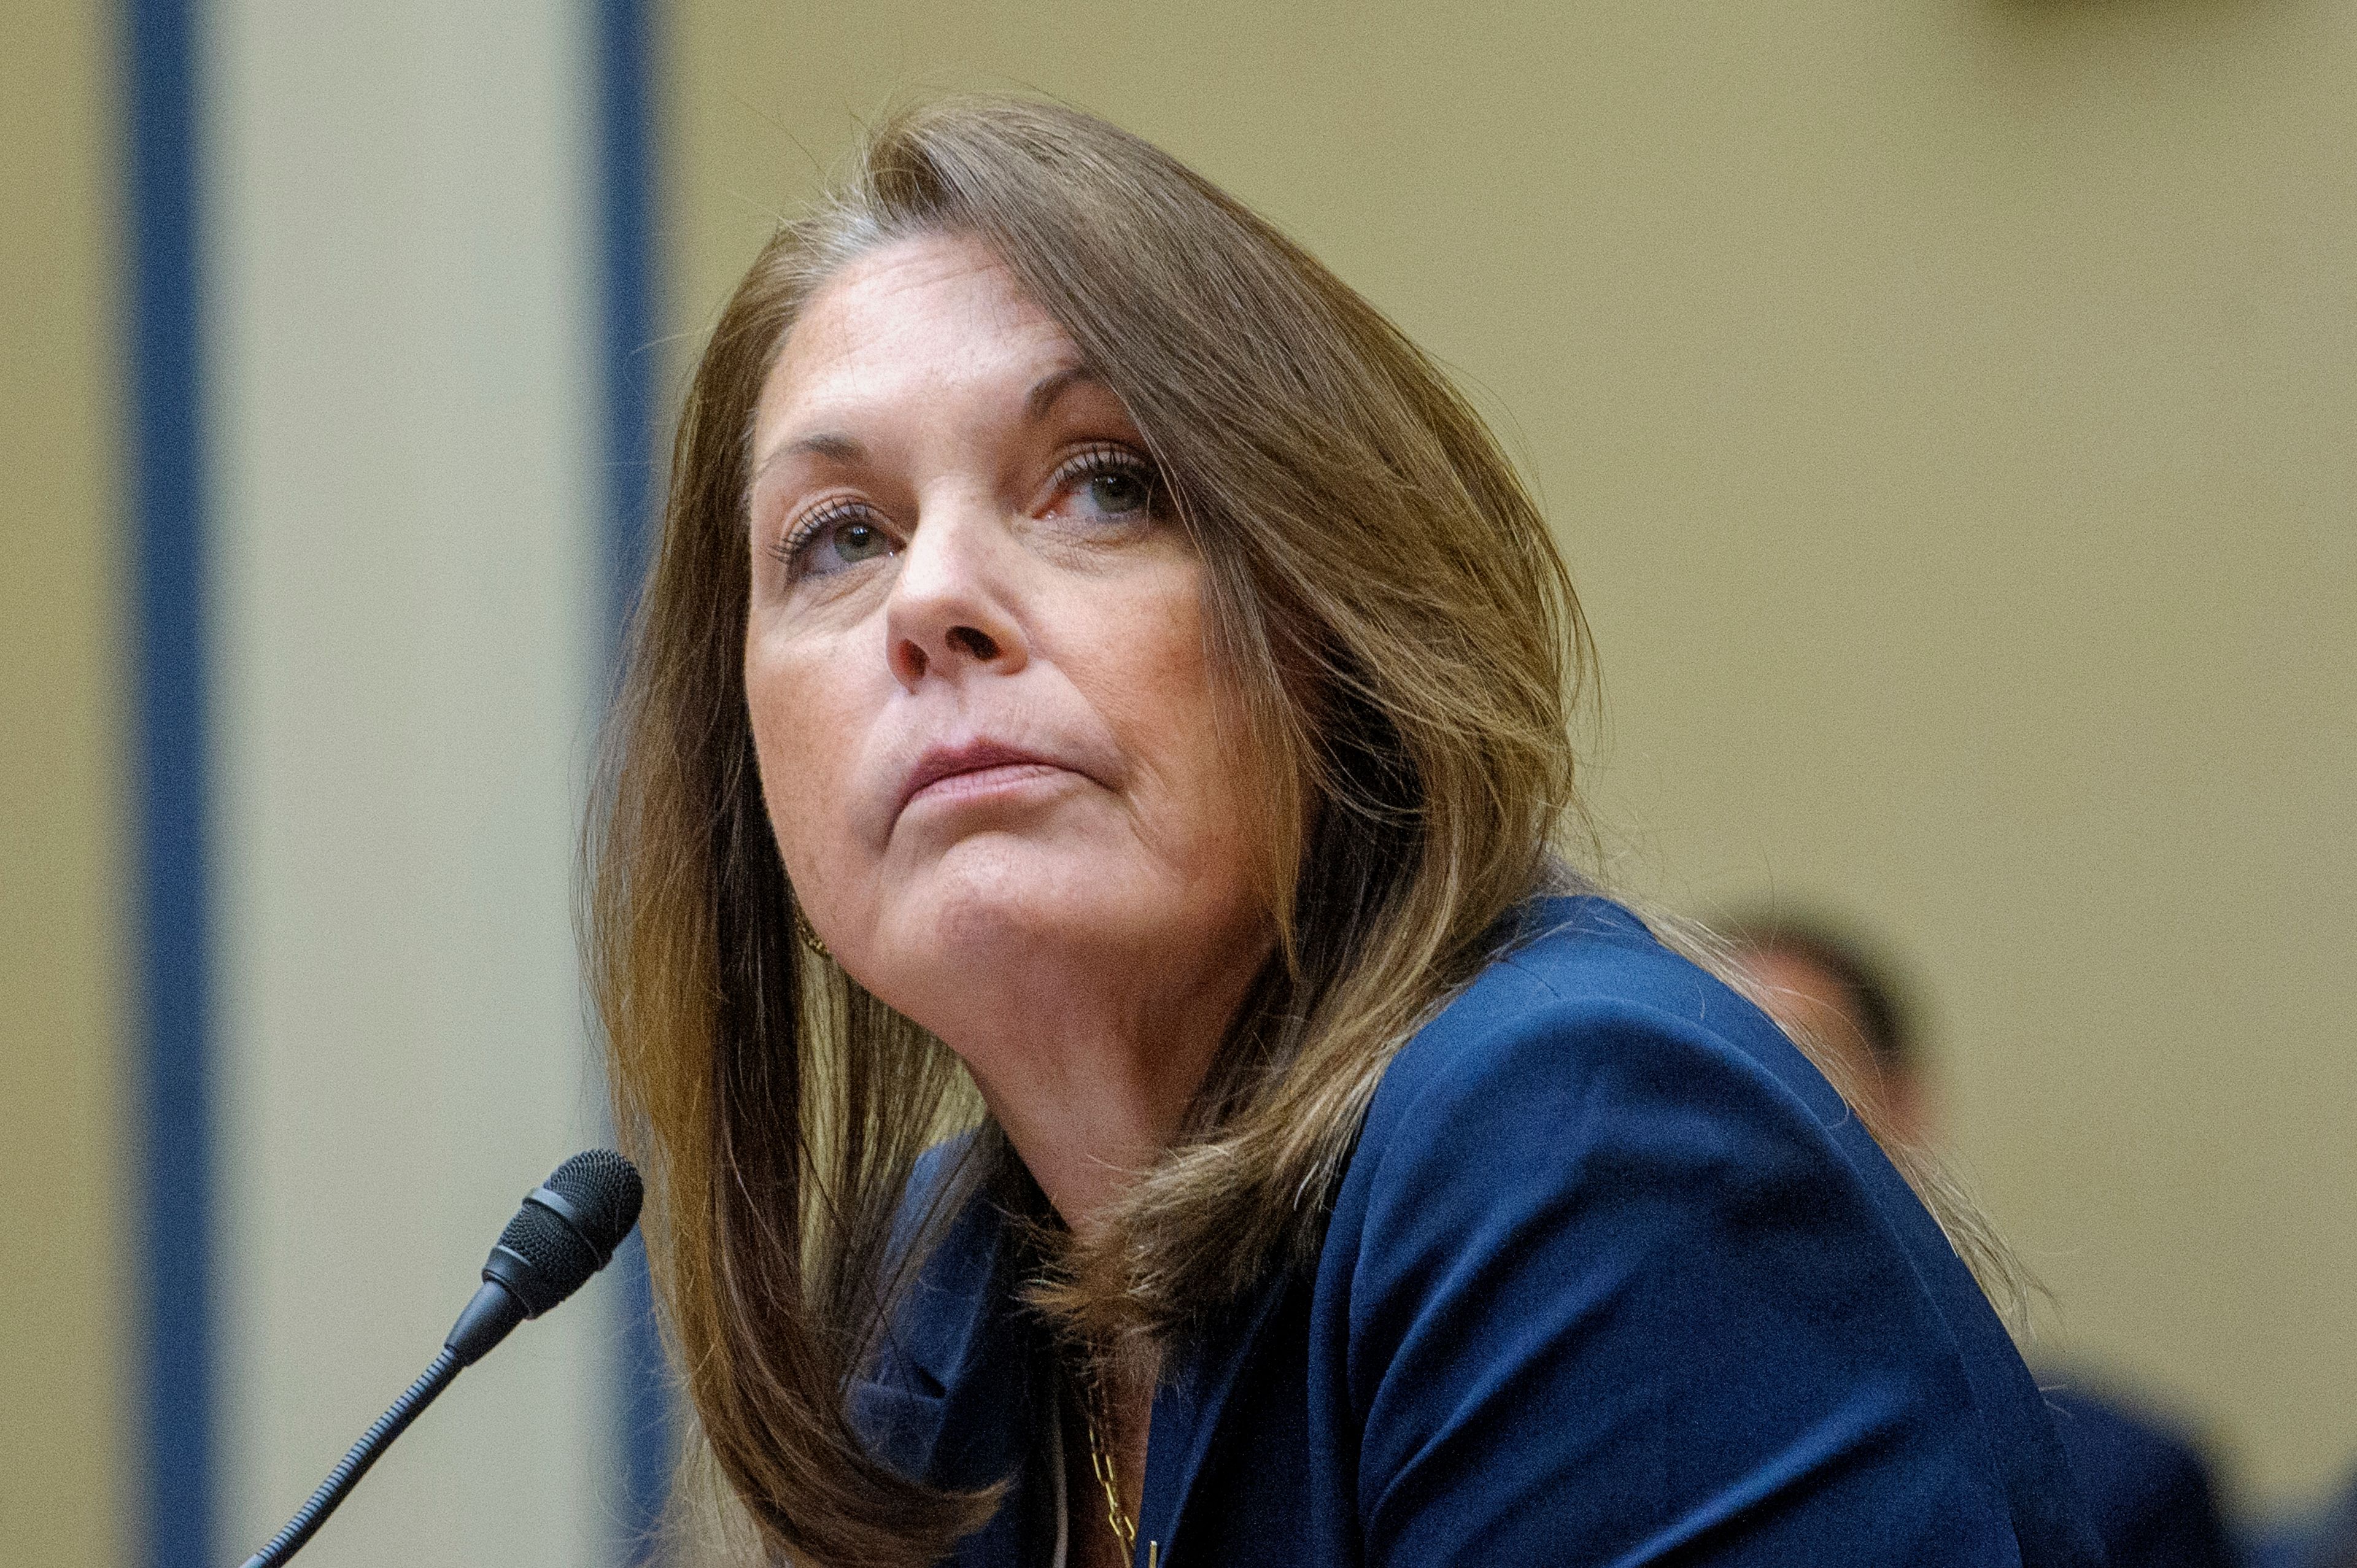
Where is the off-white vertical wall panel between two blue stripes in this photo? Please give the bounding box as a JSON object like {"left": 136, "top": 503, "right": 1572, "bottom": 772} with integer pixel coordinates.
{"left": 207, "top": 0, "right": 615, "bottom": 1568}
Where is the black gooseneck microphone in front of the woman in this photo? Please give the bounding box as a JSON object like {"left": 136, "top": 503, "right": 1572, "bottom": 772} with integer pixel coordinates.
{"left": 245, "top": 1148, "right": 643, "bottom": 1568}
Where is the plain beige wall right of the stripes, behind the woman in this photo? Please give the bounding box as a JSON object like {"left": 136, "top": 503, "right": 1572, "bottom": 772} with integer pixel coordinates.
{"left": 670, "top": 0, "right": 2357, "bottom": 1500}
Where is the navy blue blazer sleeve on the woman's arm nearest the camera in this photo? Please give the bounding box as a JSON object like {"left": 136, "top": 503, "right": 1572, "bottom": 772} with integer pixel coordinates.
{"left": 1322, "top": 976, "right": 2020, "bottom": 1568}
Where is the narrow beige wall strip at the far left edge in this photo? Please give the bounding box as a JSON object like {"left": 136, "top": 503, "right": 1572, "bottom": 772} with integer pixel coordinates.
{"left": 0, "top": 2, "right": 127, "bottom": 1566}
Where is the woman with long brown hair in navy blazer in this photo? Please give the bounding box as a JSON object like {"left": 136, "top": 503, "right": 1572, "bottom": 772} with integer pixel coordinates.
{"left": 592, "top": 99, "right": 2088, "bottom": 1568}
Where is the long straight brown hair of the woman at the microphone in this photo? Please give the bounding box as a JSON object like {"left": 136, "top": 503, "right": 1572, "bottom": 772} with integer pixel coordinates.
{"left": 587, "top": 99, "right": 1989, "bottom": 1566}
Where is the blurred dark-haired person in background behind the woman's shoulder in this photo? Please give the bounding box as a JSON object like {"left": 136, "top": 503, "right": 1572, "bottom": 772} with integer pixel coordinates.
{"left": 1718, "top": 915, "right": 2243, "bottom": 1568}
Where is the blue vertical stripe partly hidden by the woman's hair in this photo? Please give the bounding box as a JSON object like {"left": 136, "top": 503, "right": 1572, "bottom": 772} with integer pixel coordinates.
{"left": 597, "top": 0, "right": 674, "bottom": 1561}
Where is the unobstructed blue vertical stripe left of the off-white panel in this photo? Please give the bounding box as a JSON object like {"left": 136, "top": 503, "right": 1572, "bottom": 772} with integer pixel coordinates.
{"left": 123, "top": 0, "right": 217, "bottom": 1568}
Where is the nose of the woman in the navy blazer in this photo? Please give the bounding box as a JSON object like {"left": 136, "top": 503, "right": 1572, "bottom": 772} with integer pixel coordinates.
{"left": 884, "top": 507, "right": 1028, "bottom": 691}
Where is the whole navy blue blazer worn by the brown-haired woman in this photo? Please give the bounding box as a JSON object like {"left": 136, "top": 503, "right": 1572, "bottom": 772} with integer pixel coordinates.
{"left": 853, "top": 898, "right": 2100, "bottom": 1568}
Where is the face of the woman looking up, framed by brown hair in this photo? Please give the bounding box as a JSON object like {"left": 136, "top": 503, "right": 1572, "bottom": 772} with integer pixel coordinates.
{"left": 745, "top": 238, "right": 1268, "bottom": 1066}
